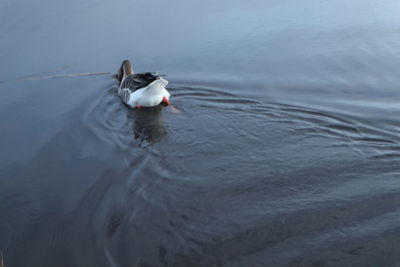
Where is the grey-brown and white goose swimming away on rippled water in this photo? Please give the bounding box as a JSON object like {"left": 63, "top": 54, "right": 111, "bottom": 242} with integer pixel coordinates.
{"left": 116, "top": 59, "right": 171, "bottom": 109}
